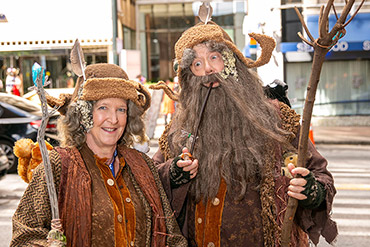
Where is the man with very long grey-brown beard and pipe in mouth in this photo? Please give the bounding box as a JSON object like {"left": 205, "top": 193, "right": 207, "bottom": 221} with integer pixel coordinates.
{"left": 153, "top": 19, "right": 337, "bottom": 246}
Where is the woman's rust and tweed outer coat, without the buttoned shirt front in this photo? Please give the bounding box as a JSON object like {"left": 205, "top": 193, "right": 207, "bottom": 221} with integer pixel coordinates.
{"left": 11, "top": 146, "right": 187, "bottom": 247}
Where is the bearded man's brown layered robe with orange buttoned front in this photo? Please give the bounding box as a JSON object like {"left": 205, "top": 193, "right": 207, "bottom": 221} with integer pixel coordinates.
{"left": 153, "top": 101, "right": 337, "bottom": 247}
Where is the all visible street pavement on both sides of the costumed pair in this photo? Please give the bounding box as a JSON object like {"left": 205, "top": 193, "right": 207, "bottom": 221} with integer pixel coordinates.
{"left": 0, "top": 144, "right": 370, "bottom": 247}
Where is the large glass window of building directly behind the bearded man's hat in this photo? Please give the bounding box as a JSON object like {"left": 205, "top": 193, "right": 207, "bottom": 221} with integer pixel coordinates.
{"left": 137, "top": 0, "right": 246, "bottom": 81}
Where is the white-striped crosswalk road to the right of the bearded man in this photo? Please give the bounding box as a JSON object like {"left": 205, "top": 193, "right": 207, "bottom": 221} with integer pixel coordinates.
{"left": 317, "top": 145, "right": 370, "bottom": 247}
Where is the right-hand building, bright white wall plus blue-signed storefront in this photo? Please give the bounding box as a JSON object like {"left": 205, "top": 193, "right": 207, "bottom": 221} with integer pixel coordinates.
{"left": 245, "top": 0, "right": 370, "bottom": 122}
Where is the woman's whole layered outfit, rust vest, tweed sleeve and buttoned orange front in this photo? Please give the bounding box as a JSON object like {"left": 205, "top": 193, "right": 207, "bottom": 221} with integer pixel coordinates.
{"left": 10, "top": 144, "right": 187, "bottom": 247}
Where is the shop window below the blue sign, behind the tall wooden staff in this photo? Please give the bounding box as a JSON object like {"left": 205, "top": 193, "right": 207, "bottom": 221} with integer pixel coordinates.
{"left": 286, "top": 60, "right": 370, "bottom": 116}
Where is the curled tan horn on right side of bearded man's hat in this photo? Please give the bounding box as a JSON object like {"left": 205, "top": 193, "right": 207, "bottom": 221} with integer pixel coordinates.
{"left": 247, "top": 33, "right": 276, "bottom": 68}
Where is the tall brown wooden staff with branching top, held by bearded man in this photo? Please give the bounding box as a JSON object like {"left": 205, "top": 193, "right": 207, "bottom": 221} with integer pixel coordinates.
{"left": 281, "top": 0, "right": 365, "bottom": 247}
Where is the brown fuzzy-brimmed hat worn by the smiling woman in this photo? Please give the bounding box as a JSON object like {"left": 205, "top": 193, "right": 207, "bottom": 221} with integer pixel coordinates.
{"left": 46, "top": 63, "right": 151, "bottom": 115}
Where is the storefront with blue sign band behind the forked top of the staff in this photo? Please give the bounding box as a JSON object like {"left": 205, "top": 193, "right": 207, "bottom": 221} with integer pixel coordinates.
{"left": 281, "top": 1, "right": 370, "bottom": 116}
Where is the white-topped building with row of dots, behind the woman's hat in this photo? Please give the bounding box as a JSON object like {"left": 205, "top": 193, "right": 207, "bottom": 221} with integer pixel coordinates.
{"left": 0, "top": 0, "right": 136, "bottom": 93}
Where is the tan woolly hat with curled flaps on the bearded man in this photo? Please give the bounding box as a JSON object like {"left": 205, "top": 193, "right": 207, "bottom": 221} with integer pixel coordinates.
{"left": 150, "top": 7, "right": 276, "bottom": 101}
